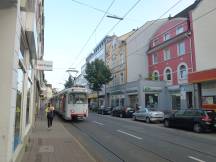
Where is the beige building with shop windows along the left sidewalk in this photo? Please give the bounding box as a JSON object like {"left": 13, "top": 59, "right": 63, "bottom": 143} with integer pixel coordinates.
{"left": 0, "top": 0, "right": 44, "bottom": 162}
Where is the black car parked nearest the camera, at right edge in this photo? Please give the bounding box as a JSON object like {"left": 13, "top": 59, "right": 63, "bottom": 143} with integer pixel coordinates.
{"left": 164, "top": 109, "right": 216, "bottom": 133}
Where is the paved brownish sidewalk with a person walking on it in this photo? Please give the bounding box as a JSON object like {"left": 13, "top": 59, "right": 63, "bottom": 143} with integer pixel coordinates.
{"left": 22, "top": 117, "right": 96, "bottom": 162}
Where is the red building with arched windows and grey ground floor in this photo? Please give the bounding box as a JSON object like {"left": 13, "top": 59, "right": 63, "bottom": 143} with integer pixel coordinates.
{"left": 148, "top": 17, "right": 195, "bottom": 109}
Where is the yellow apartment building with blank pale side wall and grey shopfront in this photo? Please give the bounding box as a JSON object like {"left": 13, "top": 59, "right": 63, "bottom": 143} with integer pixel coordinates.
{"left": 106, "top": 19, "right": 167, "bottom": 107}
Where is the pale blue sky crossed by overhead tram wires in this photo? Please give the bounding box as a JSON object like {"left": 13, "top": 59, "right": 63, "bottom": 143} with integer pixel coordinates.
{"left": 44, "top": 0, "right": 194, "bottom": 90}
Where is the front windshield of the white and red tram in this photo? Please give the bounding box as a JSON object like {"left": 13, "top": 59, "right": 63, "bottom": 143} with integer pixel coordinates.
{"left": 69, "top": 93, "right": 87, "bottom": 104}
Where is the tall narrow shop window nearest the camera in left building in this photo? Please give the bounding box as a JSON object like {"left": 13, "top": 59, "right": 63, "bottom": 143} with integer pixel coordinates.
{"left": 14, "top": 64, "right": 24, "bottom": 150}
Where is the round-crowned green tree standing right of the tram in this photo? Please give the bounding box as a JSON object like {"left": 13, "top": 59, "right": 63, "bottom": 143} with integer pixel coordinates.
{"left": 84, "top": 59, "right": 113, "bottom": 107}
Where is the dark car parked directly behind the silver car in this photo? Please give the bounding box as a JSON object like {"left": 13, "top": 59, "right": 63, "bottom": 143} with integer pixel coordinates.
{"left": 111, "top": 106, "right": 134, "bottom": 118}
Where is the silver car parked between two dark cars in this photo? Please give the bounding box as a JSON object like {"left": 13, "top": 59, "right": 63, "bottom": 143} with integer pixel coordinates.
{"left": 133, "top": 108, "right": 164, "bottom": 123}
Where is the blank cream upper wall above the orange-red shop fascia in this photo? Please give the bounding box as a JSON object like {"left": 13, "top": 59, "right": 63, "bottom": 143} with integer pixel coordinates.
{"left": 192, "top": 0, "right": 216, "bottom": 71}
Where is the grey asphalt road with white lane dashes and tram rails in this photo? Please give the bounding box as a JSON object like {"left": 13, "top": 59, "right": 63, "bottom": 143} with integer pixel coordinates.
{"left": 60, "top": 113, "right": 216, "bottom": 162}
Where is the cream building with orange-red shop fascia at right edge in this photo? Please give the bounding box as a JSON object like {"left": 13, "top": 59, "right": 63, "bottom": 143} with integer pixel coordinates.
{"left": 189, "top": 0, "right": 216, "bottom": 110}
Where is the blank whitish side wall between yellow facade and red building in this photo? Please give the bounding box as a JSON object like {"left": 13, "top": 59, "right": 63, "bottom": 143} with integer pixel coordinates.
{"left": 126, "top": 19, "right": 167, "bottom": 82}
